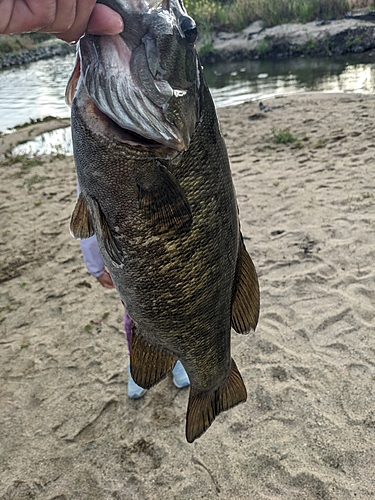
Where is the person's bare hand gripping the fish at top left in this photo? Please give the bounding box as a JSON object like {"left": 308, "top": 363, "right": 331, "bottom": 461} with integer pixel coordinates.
{"left": 0, "top": 0, "right": 124, "bottom": 42}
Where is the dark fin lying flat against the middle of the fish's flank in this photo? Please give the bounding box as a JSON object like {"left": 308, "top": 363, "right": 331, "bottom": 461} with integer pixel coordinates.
{"left": 138, "top": 162, "right": 193, "bottom": 233}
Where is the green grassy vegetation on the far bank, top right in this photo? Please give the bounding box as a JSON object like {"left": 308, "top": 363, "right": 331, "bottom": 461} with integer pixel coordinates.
{"left": 184, "top": 0, "right": 375, "bottom": 31}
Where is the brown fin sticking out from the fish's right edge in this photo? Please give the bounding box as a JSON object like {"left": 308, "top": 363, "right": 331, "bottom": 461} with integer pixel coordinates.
{"left": 232, "top": 234, "right": 259, "bottom": 333}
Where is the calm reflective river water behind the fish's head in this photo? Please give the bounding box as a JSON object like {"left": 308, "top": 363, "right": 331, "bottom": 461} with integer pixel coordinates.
{"left": 0, "top": 53, "right": 375, "bottom": 152}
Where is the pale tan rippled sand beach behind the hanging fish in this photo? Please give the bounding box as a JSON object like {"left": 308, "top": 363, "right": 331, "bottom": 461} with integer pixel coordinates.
{"left": 0, "top": 94, "right": 375, "bottom": 500}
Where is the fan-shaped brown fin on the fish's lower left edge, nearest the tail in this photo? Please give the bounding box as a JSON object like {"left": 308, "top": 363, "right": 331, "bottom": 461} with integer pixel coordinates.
{"left": 130, "top": 322, "right": 177, "bottom": 389}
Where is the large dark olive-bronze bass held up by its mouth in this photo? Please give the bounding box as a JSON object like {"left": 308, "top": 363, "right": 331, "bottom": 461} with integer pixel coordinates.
{"left": 66, "top": 0, "right": 260, "bottom": 443}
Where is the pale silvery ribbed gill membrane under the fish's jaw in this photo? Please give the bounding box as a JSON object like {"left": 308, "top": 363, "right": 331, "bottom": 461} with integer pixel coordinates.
{"left": 78, "top": 34, "right": 188, "bottom": 151}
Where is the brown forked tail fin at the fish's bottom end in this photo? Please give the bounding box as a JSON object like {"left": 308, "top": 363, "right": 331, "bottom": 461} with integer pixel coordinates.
{"left": 186, "top": 359, "right": 247, "bottom": 443}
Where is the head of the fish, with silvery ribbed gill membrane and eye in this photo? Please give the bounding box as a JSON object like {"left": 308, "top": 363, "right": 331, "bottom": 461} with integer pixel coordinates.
{"left": 67, "top": 0, "right": 202, "bottom": 152}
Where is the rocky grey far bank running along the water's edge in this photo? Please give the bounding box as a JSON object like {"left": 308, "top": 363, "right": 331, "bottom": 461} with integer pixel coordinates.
{"left": 0, "top": 16, "right": 375, "bottom": 70}
